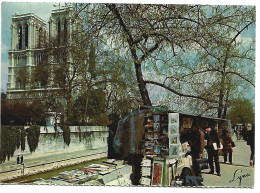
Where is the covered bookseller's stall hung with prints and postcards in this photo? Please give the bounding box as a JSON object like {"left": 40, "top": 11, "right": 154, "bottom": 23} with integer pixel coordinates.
{"left": 108, "top": 106, "right": 231, "bottom": 186}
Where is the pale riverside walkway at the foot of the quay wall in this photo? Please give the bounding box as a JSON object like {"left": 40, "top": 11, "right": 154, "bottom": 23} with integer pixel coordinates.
{"left": 0, "top": 147, "right": 107, "bottom": 182}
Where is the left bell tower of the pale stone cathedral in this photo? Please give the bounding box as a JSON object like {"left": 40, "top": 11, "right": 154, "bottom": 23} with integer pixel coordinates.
{"left": 7, "top": 13, "right": 47, "bottom": 99}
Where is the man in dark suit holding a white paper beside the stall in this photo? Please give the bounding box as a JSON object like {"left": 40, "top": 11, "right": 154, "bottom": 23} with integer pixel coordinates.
{"left": 205, "top": 123, "right": 221, "bottom": 176}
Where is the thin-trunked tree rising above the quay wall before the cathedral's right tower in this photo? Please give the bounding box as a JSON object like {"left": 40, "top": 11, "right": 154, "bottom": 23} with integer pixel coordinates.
{"left": 46, "top": 29, "right": 88, "bottom": 124}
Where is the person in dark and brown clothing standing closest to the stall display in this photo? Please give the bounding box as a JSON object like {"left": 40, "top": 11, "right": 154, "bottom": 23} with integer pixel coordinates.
{"left": 187, "top": 122, "right": 204, "bottom": 177}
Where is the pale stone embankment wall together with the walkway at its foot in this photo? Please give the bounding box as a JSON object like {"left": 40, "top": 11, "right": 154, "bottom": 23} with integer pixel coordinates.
{"left": 0, "top": 126, "right": 108, "bottom": 182}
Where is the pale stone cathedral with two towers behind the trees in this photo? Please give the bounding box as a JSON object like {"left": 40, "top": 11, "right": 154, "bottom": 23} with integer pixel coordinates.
{"left": 6, "top": 6, "right": 75, "bottom": 100}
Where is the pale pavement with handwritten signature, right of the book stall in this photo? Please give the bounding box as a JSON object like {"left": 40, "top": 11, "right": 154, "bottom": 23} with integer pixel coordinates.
{"left": 202, "top": 137, "right": 254, "bottom": 188}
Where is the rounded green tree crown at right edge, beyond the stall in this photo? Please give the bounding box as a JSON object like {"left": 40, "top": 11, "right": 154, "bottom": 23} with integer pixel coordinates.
{"left": 227, "top": 99, "right": 255, "bottom": 125}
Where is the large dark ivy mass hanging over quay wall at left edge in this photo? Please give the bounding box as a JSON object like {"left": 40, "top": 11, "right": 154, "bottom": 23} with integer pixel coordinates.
{"left": 0, "top": 126, "right": 24, "bottom": 163}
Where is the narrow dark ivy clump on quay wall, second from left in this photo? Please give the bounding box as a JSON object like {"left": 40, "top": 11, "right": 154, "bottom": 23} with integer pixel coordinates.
{"left": 26, "top": 125, "right": 40, "bottom": 152}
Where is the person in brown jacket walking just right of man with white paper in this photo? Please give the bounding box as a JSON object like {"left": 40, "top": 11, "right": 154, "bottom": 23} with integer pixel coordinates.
{"left": 221, "top": 128, "right": 234, "bottom": 164}
